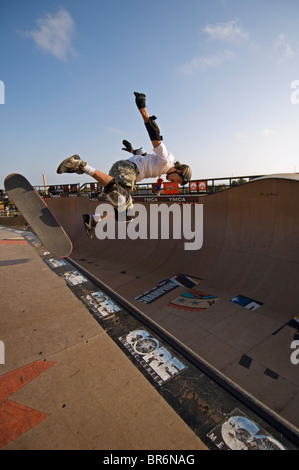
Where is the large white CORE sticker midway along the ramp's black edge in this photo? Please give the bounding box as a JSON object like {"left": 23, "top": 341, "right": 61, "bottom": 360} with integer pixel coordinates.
{"left": 118, "top": 329, "right": 186, "bottom": 385}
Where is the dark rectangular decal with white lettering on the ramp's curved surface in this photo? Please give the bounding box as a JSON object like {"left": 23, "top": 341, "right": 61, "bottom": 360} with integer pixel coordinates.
{"left": 135, "top": 274, "right": 202, "bottom": 304}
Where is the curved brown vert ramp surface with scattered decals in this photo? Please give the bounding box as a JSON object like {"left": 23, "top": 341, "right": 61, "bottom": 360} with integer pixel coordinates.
{"left": 47, "top": 174, "right": 299, "bottom": 431}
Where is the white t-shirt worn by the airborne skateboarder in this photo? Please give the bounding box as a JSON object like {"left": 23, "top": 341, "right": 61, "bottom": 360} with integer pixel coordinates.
{"left": 129, "top": 142, "right": 174, "bottom": 181}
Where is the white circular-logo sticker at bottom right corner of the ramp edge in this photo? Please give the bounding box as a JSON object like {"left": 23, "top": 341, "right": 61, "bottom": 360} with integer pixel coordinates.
{"left": 207, "top": 408, "right": 286, "bottom": 450}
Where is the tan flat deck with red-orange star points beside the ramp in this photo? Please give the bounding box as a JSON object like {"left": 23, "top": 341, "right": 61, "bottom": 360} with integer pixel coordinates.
{"left": 0, "top": 227, "right": 206, "bottom": 450}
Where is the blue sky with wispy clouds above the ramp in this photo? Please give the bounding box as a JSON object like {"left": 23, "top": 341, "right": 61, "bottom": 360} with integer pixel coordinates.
{"left": 0, "top": 0, "right": 299, "bottom": 187}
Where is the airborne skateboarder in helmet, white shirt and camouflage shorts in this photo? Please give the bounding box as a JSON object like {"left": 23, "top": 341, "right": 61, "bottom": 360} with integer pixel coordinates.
{"left": 57, "top": 92, "right": 192, "bottom": 237}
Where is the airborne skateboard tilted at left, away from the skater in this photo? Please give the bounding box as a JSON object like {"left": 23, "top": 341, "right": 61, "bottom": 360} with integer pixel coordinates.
{"left": 4, "top": 173, "right": 73, "bottom": 258}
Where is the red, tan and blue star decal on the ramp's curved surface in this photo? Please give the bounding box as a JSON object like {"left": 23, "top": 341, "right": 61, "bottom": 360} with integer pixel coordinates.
{"left": 168, "top": 290, "right": 218, "bottom": 312}
